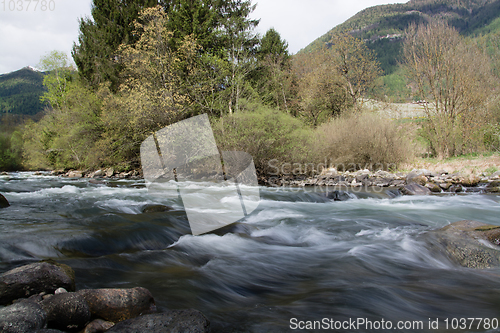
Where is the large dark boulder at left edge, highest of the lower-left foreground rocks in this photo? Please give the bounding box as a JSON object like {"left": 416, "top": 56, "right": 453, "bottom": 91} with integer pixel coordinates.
{"left": 0, "top": 261, "right": 75, "bottom": 305}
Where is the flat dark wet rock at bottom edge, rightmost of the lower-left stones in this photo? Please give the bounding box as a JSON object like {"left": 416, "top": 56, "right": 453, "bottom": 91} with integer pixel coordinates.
{"left": 106, "top": 309, "right": 210, "bottom": 333}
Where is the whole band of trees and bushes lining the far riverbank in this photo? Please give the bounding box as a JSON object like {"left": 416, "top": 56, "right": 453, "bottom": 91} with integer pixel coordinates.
{"left": 0, "top": 0, "right": 500, "bottom": 180}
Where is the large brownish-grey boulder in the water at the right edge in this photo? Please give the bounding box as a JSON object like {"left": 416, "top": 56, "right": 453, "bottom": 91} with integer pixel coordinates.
{"left": 427, "top": 221, "right": 500, "bottom": 268}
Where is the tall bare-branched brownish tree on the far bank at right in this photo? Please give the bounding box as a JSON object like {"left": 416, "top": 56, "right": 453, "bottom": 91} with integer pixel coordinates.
{"left": 403, "top": 21, "right": 495, "bottom": 157}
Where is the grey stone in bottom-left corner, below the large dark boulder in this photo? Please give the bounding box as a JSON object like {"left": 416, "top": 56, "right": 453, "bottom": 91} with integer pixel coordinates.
{"left": 0, "top": 301, "right": 47, "bottom": 333}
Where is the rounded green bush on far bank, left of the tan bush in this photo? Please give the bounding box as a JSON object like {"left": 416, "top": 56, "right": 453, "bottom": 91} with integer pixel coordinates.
{"left": 212, "top": 105, "right": 313, "bottom": 176}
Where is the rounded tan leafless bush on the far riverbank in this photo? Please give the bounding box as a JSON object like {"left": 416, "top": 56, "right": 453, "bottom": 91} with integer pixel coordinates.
{"left": 317, "top": 112, "right": 415, "bottom": 170}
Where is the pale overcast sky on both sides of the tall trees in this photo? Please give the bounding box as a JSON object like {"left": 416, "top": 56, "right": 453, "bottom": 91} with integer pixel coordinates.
{"left": 0, "top": 0, "right": 406, "bottom": 74}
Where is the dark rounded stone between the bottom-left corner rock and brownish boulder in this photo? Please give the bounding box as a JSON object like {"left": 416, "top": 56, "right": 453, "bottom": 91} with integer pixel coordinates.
{"left": 40, "top": 293, "right": 90, "bottom": 331}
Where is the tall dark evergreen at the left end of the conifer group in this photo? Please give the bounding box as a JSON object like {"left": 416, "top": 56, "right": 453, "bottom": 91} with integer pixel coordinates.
{"left": 72, "top": 0, "right": 158, "bottom": 91}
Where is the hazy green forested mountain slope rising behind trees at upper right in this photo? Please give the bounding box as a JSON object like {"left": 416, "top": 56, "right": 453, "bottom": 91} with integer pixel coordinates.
{"left": 300, "top": 0, "right": 500, "bottom": 74}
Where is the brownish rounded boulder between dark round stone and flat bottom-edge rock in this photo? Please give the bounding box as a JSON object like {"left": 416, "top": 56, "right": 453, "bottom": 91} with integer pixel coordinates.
{"left": 76, "top": 287, "right": 156, "bottom": 322}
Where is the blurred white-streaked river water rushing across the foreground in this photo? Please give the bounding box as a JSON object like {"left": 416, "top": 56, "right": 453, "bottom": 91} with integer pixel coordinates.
{"left": 0, "top": 173, "right": 500, "bottom": 332}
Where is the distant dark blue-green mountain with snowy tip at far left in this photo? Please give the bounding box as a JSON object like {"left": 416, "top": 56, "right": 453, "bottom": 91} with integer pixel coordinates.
{"left": 0, "top": 66, "right": 45, "bottom": 116}
